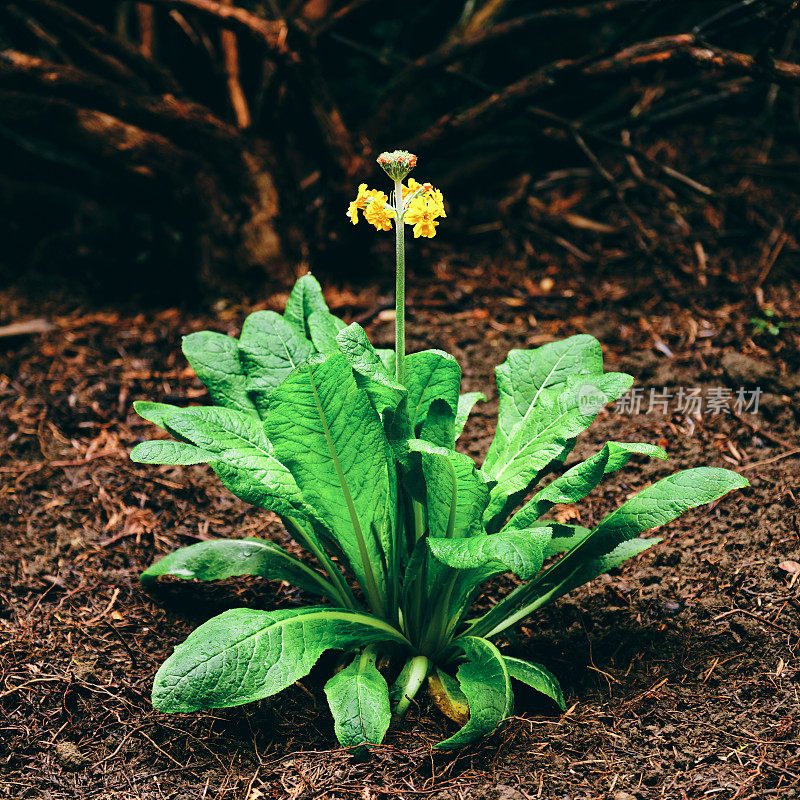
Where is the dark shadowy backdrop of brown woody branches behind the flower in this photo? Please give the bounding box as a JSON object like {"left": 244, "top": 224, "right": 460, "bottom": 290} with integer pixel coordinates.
{"left": 0, "top": 0, "right": 800, "bottom": 302}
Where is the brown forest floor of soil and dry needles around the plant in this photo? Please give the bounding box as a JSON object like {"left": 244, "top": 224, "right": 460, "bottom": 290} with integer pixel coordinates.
{"left": 0, "top": 258, "right": 800, "bottom": 800}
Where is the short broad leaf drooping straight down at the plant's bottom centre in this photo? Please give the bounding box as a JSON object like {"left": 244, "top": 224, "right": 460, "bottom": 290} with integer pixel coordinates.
{"left": 325, "top": 648, "right": 392, "bottom": 752}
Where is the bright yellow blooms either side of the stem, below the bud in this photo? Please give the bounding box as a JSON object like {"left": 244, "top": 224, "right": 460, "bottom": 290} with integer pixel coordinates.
{"left": 347, "top": 178, "right": 447, "bottom": 234}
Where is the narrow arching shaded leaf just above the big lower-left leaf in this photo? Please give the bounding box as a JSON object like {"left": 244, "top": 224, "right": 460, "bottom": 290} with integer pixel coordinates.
{"left": 139, "top": 539, "right": 333, "bottom": 597}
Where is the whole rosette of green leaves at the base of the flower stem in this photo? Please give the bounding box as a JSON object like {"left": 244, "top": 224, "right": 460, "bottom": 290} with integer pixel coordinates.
{"left": 131, "top": 275, "right": 747, "bottom": 749}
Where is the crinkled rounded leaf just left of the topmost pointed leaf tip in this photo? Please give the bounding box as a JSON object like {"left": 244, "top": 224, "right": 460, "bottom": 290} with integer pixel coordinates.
{"left": 239, "top": 311, "right": 313, "bottom": 417}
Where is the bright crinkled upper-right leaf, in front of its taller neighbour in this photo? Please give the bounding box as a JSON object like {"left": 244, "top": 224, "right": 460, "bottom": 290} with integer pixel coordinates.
{"left": 484, "top": 372, "right": 633, "bottom": 533}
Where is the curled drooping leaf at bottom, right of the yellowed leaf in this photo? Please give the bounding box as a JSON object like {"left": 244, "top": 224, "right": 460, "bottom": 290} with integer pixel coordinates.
{"left": 435, "top": 636, "right": 514, "bottom": 750}
